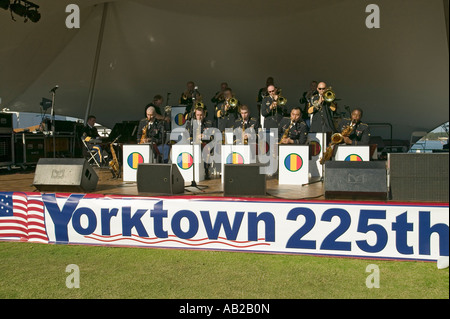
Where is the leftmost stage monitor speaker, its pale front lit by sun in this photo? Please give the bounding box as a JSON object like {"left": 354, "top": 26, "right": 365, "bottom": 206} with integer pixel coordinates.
{"left": 33, "top": 158, "right": 98, "bottom": 193}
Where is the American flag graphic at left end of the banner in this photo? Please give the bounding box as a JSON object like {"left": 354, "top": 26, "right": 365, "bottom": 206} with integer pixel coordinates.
{"left": 0, "top": 192, "right": 48, "bottom": 243}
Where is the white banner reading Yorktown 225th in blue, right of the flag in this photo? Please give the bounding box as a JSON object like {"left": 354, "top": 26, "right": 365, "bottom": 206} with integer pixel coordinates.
{"left": 0, "top": 193, "right": 449, "bottom": 260}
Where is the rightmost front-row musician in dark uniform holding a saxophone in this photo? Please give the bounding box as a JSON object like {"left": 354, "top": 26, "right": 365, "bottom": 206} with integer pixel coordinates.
{"left": 338, "top": 108, "right": 370, "bottom": 145}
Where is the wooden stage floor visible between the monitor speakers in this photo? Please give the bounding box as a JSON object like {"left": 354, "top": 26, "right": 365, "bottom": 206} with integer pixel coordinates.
{"left": 0, "top": 168, "right": 325, "bottom": 200}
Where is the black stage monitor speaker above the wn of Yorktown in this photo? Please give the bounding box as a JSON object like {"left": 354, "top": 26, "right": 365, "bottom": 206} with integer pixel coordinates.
{"left": 223, "top": 164, "right": 266, "bottom": 196}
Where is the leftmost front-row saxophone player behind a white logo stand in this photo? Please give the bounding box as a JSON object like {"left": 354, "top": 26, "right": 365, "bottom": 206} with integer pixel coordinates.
{"left": 137, "top": 106, "right": 164, "bottom": 162}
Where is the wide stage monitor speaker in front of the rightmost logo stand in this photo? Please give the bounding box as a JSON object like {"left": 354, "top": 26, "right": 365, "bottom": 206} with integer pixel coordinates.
{"left": 325, "top": 161, "right": 388, "bottom": 200}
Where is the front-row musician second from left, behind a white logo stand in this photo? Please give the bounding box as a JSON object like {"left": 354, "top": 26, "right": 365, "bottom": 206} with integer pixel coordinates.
{"left": 186, "top": 107, "right": 212, "bottom": 179}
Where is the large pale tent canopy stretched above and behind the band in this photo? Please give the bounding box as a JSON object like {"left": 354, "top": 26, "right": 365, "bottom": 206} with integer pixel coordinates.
{"left": 0, "top": 0, "right": 449, "bottom": 140}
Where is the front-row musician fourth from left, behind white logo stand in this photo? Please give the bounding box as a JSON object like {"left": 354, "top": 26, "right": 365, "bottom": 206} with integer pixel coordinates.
{"left": 278, "top": 106, "right": 308, "bottom": 145}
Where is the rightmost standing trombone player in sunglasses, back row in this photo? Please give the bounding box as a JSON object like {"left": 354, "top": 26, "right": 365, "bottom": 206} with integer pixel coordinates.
{"left": 308, "top": 82, "right": 336, "bottom": 133}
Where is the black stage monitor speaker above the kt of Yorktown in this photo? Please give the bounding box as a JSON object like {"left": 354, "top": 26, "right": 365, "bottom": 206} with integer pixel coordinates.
{"left": 137, "top": 164, "right": 184, "bottom": 195}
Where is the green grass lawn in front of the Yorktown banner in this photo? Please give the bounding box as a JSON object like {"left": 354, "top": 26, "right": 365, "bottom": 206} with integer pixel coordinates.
{"left": 0, "top": 242, "right": 449, "bottom": 299}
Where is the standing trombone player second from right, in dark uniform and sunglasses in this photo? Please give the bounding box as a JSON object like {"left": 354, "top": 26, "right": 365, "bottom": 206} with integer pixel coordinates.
{"left": 261, "top": 84, "right": 288, "bottom": 129}
